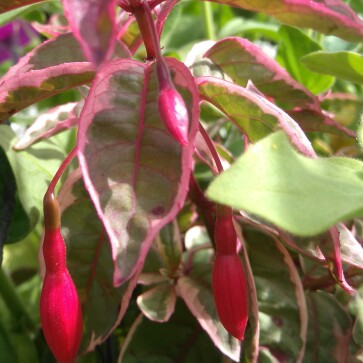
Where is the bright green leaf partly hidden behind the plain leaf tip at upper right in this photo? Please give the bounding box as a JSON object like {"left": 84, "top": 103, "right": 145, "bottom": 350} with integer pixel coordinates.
{"left": 277, "top": 25, "right": 334, "bottom": 94}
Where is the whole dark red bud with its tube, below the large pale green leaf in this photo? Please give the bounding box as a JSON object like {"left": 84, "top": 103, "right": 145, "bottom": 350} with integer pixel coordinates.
{"left": 212, "top": 206, "right": 248, "bottom": 340}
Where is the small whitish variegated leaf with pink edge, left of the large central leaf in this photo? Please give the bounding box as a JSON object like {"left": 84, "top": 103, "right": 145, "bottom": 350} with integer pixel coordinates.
{"left": 14, "top": 102, "right": 83, "bottom": 150}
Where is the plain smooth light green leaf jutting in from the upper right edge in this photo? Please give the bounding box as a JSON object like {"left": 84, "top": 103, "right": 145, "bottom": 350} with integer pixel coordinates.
{"left": 301, "top": 52, "right": 363, "bottom": 84}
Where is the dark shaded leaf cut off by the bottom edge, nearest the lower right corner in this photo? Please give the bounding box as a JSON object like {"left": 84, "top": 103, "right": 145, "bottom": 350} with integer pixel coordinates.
{"left": 303, "top": 291, "right": 351, "bottom": 363}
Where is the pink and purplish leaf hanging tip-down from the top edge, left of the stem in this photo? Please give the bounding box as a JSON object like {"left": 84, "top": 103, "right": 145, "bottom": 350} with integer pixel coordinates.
{"left": 63, "top": 0, "right": 117, "bottom": 68}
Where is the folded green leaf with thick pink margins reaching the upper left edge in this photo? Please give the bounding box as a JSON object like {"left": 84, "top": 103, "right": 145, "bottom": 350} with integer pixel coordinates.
{"left": 0, "top": 34, "right": 130, "bottom": 122}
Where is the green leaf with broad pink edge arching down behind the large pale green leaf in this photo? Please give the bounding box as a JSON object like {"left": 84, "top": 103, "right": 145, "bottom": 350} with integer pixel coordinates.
{"left": 196, "top": 77, "right": 316, "bottom": 158}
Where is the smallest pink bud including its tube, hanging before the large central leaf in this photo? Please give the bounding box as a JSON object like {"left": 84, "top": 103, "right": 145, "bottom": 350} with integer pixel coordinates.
{"left": 156, "top": 59, "right": 189, "bottom": 146}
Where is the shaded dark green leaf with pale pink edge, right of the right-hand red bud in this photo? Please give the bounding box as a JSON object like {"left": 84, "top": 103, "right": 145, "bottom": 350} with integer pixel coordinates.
{"left": 244, "top": 229, "right": 307, "bottom": 362}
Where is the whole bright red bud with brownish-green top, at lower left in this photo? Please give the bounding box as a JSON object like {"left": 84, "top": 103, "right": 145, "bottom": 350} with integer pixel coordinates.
{"left": 40, "top": 194, "right": 82, "bottom": 363}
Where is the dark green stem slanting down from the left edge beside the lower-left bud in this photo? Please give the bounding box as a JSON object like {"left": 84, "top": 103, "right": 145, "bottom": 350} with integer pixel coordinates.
{"left": 0, "top": 269, "right": 35, "bottom": 331}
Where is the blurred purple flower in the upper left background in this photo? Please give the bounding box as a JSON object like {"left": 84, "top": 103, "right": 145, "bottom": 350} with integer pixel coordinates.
{"left": 0, "top": 20, "right": 37, "bottom": 63}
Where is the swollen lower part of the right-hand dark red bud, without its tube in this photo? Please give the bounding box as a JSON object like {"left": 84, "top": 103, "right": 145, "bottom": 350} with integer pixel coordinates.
{"left": 212, "top": 253, "right": 248, "bottom": 340}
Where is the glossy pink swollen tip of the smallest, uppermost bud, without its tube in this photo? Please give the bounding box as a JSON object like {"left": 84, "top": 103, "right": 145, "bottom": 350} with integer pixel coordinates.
{"left": 158, "top": 87, "right": 189, "bottom": 146}
